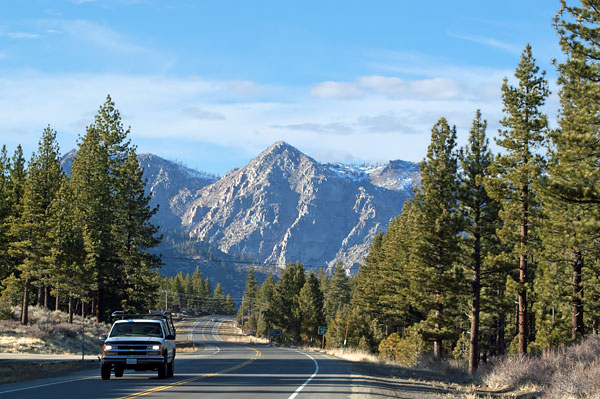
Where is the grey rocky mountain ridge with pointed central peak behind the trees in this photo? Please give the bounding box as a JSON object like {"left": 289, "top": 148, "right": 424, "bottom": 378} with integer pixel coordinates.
{"left": 63, "top": 142, "right": 419, "bottom": 274}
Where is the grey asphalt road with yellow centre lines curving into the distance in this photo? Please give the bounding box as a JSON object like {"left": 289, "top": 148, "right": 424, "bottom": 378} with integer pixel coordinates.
{"left": 0, "top": 318, "right": 352, "bottom": 399}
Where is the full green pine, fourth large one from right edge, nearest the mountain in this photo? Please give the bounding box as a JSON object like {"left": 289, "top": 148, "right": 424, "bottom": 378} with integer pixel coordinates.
{"left": 409, "top": 118, "right": 464, "bottom": 359}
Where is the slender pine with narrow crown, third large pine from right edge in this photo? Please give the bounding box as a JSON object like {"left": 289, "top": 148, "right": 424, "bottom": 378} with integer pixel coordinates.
{"left": 459, "top": 110, "right": 499, "bottom": 374}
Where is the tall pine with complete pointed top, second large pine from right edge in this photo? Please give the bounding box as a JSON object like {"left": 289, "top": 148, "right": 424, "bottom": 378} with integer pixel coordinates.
{"left": 486, "top": 45, "right": 549, "bottom": 354}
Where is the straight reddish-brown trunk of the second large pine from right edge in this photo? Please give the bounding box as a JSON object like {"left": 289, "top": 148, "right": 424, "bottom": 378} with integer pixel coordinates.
{"left": 519, "top": 191, "right": 529, "bottom": 355}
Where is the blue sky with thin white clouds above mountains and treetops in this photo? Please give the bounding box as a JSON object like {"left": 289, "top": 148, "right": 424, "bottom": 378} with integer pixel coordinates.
{"left": 0, "top": 0, "right": 561, "bottom": 174}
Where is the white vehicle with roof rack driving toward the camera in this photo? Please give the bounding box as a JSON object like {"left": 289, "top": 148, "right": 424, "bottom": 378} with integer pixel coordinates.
{"left": 100, "top": 311, "right": 176, "bottom": 380}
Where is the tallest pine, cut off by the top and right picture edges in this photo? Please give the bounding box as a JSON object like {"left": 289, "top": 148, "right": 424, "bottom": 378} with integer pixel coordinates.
{"left": 543, "top": 0, "right": 600, "bottom": 340}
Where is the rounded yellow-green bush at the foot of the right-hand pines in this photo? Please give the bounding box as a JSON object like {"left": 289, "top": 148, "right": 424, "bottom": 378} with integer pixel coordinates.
{"left": 379, "top": 326, "right": 425, "bottom": 367}
